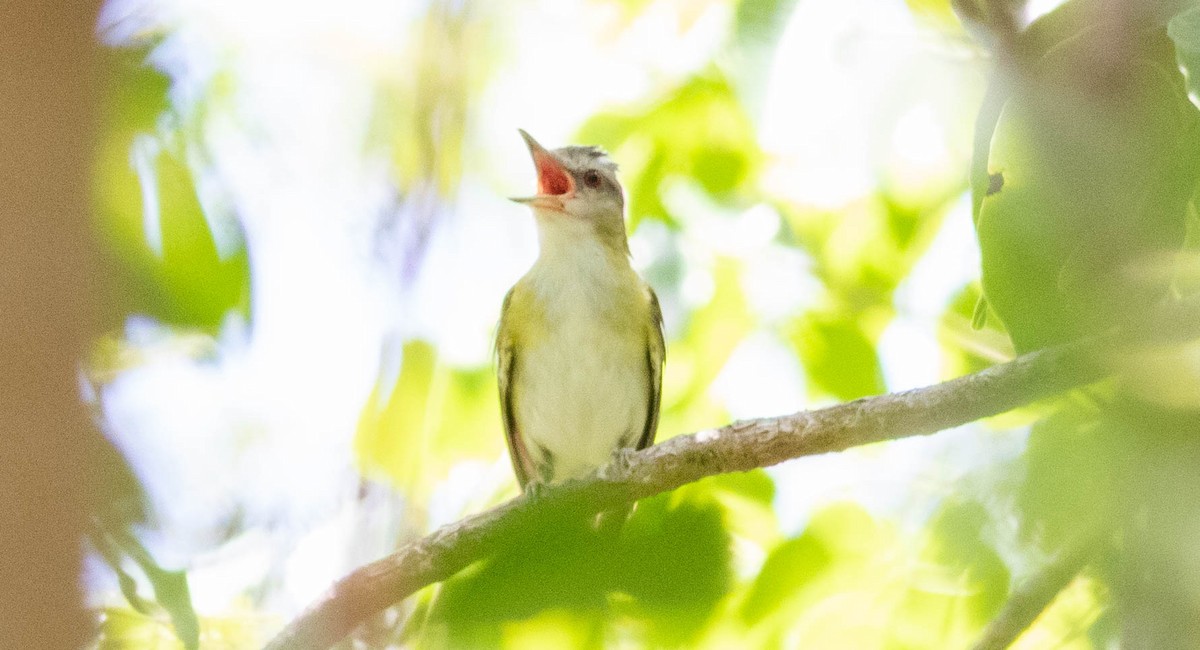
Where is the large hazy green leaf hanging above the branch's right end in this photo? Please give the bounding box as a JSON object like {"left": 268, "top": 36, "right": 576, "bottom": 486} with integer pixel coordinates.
{"left": 978, "top": 30, "right": 1200, "bottom": 351}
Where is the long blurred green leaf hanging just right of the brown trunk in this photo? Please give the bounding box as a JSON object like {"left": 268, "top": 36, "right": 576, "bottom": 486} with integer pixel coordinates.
{"left": 94, "top": 48, "right": 250, "bottom": 331}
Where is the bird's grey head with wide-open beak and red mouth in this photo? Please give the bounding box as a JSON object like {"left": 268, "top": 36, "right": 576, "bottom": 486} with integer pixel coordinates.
{"left": 512, "top": 131, "right": 628, "bottom": 249}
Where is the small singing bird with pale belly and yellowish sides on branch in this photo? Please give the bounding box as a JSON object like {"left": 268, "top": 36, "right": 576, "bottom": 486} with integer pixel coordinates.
{"left": 496, "top": 131, "right": 665, "bottom": 488}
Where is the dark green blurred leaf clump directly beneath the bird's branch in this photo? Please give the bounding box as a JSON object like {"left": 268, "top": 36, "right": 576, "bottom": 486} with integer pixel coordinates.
{"left": 424, "top": 494, "right": 731, "bottom": 648}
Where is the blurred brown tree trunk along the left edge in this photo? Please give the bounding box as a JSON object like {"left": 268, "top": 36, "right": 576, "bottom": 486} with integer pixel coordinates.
{"left": 0, "top": 0, "right": 96, "bottom": 649}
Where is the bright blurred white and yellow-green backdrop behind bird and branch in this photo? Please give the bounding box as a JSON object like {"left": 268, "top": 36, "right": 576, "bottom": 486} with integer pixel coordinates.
{"left": 9, "top": 0, "right": 1200, "bottom": 649}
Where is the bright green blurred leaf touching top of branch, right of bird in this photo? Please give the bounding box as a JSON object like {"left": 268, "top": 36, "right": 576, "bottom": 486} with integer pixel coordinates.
{"left": 788, "top": 312, "right": 886, "bottom": 401}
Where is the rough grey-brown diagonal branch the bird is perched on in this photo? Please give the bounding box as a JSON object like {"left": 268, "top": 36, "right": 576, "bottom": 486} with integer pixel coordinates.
{"left": 266, "top": 341, "right": 1110, "bottom": 650}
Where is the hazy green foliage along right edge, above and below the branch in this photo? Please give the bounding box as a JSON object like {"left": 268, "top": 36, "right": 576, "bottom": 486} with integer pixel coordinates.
{"left": 977, "top": 0, "right": 1200, "bottom": 648}
